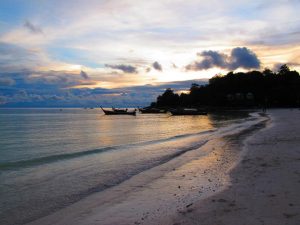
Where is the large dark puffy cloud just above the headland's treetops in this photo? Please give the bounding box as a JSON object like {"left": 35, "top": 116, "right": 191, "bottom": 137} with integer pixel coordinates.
{"left": 186, "top": 47, "right": 260, "bottom": 71}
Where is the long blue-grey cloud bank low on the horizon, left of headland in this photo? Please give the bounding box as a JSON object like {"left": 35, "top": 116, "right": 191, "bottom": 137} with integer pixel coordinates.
{"left": 0, "top": 71, "right": 207, "bottom": 107}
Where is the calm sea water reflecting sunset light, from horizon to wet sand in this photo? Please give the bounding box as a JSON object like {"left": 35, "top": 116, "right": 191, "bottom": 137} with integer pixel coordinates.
{"left": 0, "top": 109, "right": 245, "bottom": 224}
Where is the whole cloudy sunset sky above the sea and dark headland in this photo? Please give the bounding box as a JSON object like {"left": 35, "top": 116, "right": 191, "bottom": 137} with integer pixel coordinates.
{"left": 0, "top": 0, "right": 300, "bottom": 107}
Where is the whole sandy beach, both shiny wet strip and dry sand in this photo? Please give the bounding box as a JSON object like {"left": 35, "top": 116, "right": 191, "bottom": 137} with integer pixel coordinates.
{"left": 30, "top": 109, "right": 300, "bottom": 225}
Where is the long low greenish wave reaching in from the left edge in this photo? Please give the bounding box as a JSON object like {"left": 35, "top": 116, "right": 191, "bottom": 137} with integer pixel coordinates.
{"left": 0, "top": 129, "right": 215, "bottom": 171}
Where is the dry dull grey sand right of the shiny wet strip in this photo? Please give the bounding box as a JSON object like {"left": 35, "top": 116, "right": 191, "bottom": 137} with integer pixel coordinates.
{"left": 165, "top": 109, "right": 300, "bottom": 225}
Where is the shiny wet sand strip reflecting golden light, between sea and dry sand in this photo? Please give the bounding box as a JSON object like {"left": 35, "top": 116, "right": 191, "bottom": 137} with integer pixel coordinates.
{"left": 25, "top": 110, "right": 266, "bottom": 225}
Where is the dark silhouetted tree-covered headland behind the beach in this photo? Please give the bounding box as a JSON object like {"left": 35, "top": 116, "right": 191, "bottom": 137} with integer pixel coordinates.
{"left": 150, "top": 65, "right": 300, "bottom": 108}
